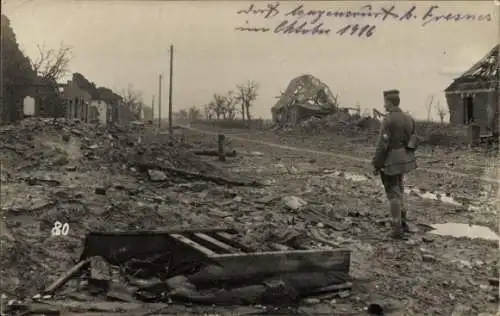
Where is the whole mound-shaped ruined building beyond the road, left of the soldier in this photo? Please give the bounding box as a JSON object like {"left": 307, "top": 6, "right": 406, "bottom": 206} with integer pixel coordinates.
{"left": 271, "top": 75, "right": 338, "bottom": 126}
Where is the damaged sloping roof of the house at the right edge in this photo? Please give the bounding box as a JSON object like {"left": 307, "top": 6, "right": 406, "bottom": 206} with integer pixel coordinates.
{"left": 445, "top": 45, "right": 500, "bottom": 92}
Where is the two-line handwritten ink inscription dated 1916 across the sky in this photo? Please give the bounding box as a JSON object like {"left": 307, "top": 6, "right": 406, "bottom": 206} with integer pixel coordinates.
{"left": 235, "top": 2, "right": 493, "bottom": 38}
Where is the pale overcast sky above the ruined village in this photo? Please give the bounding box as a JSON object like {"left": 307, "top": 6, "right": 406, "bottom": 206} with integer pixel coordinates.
{"left": 2, "top": 0, "right": 500, "bottom": 118}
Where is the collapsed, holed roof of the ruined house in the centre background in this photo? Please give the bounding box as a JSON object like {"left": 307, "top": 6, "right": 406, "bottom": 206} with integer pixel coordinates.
{"left": 271, "top": 75, "right": 337, "bottom": 112}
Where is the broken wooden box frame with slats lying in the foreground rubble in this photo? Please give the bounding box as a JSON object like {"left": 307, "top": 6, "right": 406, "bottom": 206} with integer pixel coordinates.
{"left": 8, "top": 228, "right": 352, "bottom": 315}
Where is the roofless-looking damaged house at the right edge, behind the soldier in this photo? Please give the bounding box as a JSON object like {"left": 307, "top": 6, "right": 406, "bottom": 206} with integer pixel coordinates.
{"left": 445, "top": 45, "right": 500, "bottom": 134}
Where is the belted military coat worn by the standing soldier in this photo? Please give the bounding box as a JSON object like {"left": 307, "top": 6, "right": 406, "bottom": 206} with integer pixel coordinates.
{"left": 372, "top": 107, "right": 417, "bottom": 176}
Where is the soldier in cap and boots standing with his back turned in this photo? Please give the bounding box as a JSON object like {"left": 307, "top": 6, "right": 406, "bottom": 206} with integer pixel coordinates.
{"left": 372, "top": 90, "right": 418, "bottom": 238}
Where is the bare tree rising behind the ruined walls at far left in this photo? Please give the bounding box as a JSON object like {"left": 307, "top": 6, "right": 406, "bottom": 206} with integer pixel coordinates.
{"left": 29, "top": 43, "right": 71, "bottom": 81}
